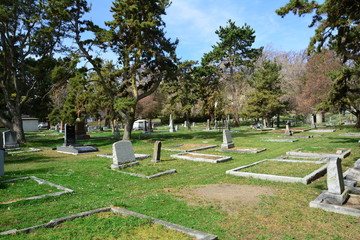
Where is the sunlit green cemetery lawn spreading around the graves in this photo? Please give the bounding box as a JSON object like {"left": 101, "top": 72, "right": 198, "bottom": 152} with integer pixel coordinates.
{"left": 0, "top": 126, "right": 360, "bottom": 240}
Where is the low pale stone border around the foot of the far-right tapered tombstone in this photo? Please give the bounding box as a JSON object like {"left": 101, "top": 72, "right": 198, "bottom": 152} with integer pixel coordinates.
{"left": 309, "top": 193, "right": 360, "bottom": 217}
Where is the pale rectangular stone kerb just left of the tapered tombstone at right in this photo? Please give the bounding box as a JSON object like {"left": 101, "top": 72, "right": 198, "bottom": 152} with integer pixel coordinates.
{"left": 225, "top": 159, "right": 327, "bottom": 184}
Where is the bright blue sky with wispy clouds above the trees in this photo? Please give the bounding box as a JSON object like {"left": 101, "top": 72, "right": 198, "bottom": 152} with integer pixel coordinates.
{"left": 89, "top": 0, "right": 314, "bottom": 60}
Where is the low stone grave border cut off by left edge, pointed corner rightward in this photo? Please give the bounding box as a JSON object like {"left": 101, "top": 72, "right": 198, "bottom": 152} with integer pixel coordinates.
{"left": 0, "top": 176, "right": 74, "bottom": 204}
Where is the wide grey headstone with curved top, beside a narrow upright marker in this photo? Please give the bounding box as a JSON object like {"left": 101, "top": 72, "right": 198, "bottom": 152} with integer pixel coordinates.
{"left": 111, "top": 140, "right": 139, "bottom": 169}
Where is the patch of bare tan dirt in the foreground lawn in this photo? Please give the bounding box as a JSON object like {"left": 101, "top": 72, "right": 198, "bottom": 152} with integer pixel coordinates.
{"left": 169, "top": 184, "right": 276, "bottom": 214}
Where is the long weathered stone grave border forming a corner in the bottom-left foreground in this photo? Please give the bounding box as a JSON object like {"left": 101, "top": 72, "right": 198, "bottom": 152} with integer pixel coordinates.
{"left": 0, "top": 207, "right": 218, "bottom": 240}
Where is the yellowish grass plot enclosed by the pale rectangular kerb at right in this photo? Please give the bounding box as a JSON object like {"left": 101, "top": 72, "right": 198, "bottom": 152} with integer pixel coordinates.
{"left": 239, "top": 161, "right": 324, "bottom": 177}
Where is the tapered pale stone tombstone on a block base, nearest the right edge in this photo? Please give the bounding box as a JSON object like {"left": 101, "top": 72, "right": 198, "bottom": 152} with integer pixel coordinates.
{"left": 324, "top": 158, "right": 349, "bottom": 205}
